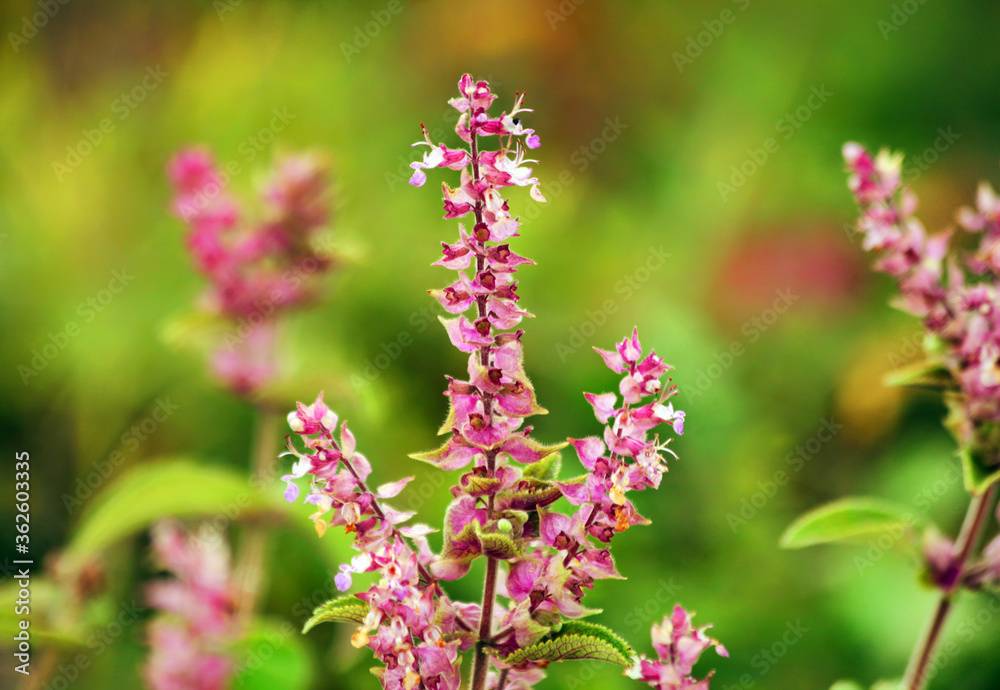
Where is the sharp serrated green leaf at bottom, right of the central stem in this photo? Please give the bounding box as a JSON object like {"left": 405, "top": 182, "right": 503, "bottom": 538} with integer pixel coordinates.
{"left": 490, "top": 620, "right": 633, "bottom": 668}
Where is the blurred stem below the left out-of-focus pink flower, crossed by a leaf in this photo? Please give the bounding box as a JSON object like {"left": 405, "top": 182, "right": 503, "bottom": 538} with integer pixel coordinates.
{"left": 235, "top": 408, "right": 281, "bottom": 619}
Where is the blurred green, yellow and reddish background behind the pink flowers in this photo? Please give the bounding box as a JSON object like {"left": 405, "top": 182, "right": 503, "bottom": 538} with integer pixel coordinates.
{"left": 0, "top": 0, "right": 1000, "bottom": 690}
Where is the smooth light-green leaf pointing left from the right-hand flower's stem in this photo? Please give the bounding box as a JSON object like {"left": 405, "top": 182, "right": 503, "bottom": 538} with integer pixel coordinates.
{"left": 781, "top": 497, "right": 914, "bottom": 549}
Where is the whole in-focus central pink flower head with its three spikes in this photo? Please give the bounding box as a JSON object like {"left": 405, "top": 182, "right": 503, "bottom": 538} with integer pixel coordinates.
{"left": 284, "top": 75, "right": 720, "bottom": 690}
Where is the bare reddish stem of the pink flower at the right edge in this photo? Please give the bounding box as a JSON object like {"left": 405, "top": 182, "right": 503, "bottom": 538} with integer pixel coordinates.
{"left": 901, "top": 485, "right": 997, "bottom": 690}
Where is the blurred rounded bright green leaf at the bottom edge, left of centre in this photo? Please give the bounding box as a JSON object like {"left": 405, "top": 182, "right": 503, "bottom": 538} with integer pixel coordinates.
{"left": 231, "top": 620, "right": 313, "bottom": 690}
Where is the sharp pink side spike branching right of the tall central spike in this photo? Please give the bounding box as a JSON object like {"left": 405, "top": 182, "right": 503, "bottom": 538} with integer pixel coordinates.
{"left": 504, "top": 332, "right": 684, "bottom": 645}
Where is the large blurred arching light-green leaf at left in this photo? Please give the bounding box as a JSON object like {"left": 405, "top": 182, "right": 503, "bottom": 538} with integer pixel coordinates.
{"left": 64, "top": 458, "right": 282, "bottom": 563}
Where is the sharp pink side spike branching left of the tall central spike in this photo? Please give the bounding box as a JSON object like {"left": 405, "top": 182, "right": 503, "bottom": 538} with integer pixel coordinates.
{"left": 282, "top": 395, "right": 474, "bottom": 690}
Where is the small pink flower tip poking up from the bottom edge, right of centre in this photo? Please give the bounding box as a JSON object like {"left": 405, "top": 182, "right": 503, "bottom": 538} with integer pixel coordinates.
{"left": 626, "top": 606, "right": 729, "bottom": 690}
